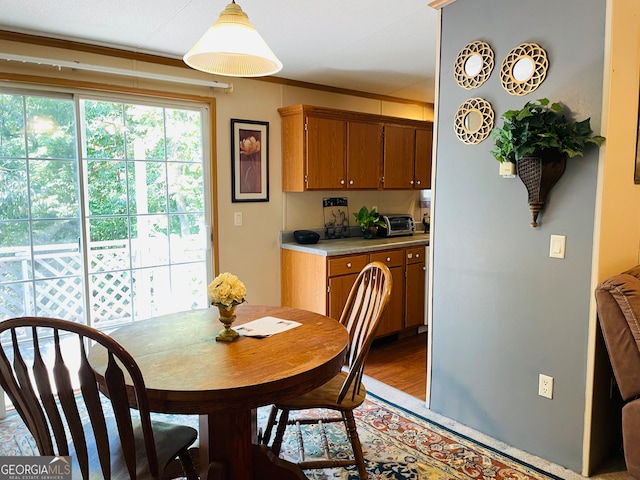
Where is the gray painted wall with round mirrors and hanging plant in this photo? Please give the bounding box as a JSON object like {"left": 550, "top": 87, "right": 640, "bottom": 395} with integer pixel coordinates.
{"left": 431, "top": 0, "right": 606, "bottom": 472}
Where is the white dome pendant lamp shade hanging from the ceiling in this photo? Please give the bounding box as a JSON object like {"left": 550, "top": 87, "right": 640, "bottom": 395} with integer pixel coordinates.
{"left": 183, "top": 1, "right": 282, "bottom": 77}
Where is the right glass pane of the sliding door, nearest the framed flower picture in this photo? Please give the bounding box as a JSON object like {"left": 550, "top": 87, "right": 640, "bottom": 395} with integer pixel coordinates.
{"left": 80, "top": 99, "right": 209, "bottom": 326}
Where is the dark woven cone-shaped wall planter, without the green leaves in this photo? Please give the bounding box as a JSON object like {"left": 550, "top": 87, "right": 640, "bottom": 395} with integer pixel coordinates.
{"left": 517, "top": 152, "right": 567, "bottom": 228}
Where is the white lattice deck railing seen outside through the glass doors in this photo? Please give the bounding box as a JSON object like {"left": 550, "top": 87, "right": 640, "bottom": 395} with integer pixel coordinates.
{"left": 0, "top": 236, "right": 206, "bottom": 328}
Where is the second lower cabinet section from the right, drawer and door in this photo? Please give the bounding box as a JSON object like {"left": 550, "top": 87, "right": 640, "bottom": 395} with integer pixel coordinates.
{"left": 369, "top": 248, "right": 404, "bottom": 337}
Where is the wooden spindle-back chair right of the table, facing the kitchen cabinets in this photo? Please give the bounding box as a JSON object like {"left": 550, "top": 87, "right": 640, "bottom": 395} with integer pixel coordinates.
{"left": 262, "top": 262, "right": 393, "bottom": 480}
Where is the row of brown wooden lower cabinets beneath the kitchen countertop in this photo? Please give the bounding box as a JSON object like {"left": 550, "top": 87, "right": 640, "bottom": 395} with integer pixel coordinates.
{"left": 280, "top": 246, "right": 426, "bottom": 337}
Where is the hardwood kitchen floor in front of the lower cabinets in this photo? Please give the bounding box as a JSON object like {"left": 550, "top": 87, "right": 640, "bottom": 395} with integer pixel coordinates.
{"left": 364, "top": 333, "right": 427, "bottom": 400}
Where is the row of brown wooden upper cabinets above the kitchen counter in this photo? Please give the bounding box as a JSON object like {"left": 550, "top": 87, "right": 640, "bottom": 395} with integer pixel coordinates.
{"left": 278, "top": 105, "right": 432, "bottom": 192}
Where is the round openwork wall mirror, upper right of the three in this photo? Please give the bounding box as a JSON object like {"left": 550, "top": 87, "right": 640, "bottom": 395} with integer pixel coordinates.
{"left": 500, "top": 43, "right": 549, "bottom": 96}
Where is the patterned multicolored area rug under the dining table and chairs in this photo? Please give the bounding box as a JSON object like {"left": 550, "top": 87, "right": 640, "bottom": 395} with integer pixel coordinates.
{"left": 0, "top": 393, "right": 560, "bottom": 480}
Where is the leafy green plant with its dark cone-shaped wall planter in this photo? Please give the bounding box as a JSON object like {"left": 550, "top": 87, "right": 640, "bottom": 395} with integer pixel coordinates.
{"left": 491, "top": 98, "right": 605, "bottom": 227}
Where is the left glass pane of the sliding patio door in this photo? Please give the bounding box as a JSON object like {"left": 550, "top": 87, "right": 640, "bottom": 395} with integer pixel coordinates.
{"left": 0, "top": 93, "right": 86, "bottom": 321}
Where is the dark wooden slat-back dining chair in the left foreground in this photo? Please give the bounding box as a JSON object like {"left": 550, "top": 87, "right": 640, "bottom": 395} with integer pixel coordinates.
{"left": 0, "top": 317, "right": 198, "bottom": 479}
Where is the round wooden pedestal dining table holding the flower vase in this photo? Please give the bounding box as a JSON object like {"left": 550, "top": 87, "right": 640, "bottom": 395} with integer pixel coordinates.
{"left": 89, "top": 304, "right": 349, "bottom": 480}
